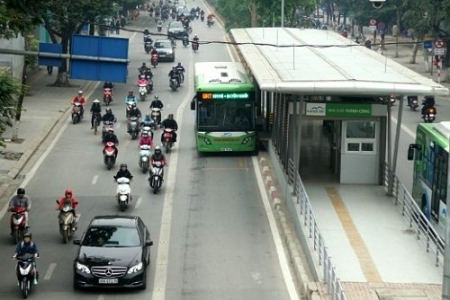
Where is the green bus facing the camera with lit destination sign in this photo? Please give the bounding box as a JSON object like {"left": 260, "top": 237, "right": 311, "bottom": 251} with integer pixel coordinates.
{"left": 191, "top": 62, "right": 256, "bottom": 152}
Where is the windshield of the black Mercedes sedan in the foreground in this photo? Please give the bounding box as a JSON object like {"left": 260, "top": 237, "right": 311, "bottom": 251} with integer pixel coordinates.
{"left": 81, "top": 226, "right": 141, "bottom": 247}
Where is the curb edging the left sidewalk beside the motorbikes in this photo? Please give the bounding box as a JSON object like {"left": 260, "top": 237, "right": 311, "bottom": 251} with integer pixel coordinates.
{"left": 0, "top": 81, "right": 96, "bottom": 199}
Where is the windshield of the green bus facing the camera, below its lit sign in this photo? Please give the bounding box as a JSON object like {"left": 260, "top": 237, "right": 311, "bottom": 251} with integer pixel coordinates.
{"left": 197, "top": 100, "right": 255, "bottom": 131}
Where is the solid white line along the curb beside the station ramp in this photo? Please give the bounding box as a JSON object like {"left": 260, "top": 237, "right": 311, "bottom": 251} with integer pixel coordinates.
{"left": 252, "top": 156, "right": 300, "bottom": 300}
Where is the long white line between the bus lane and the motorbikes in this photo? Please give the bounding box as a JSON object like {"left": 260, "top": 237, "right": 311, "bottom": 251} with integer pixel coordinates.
{"left": 151, "top": 51, "right": 194, "bottom": 300}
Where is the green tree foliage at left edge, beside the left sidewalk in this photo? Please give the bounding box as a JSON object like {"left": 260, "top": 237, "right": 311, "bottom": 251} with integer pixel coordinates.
{"left": 0, "top": 71, "right": 22, "bottom": 147}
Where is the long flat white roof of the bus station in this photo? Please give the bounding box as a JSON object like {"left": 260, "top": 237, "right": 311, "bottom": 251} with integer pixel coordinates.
{"left": 231, "top": 28, "right": 449, "bottom": 96}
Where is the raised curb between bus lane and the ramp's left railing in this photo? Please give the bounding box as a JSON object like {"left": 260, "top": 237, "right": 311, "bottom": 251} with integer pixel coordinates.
{"left": 259, "top": 157, "right": 319, "bottom": 299}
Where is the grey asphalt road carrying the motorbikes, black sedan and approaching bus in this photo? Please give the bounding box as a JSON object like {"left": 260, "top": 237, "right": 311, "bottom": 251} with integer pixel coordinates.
{"left": 0, "top": 2, "right": 295, "bottom": 300}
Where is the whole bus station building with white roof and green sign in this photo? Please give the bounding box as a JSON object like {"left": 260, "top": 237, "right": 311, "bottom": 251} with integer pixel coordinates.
{"left": 231, "top": 28, "right": 449, "bottom": 185}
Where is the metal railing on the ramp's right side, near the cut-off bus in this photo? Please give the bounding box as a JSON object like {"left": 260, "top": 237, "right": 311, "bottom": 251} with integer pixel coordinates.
{"left": 384, "top": 164, "right": 445, "bottom": 267}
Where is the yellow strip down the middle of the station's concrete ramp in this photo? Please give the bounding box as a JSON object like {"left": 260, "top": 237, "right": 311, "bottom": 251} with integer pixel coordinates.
{"left": 325, "top": 187, "right": 383, "bottom": 282}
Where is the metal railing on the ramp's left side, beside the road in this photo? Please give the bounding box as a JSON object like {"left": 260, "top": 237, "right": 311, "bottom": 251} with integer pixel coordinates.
{"left": 288, "top": 159, "right": 347, "bottom": 300}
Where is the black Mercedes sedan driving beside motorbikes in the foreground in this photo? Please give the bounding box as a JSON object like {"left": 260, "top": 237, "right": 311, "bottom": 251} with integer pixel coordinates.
{"left": 73, "top": 216, "right": 153, "bottom": 289}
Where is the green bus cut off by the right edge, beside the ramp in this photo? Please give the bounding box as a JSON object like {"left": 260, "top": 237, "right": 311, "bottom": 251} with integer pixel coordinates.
{"left": 408, "top": 122, "right": 450, "bottom": 237}
